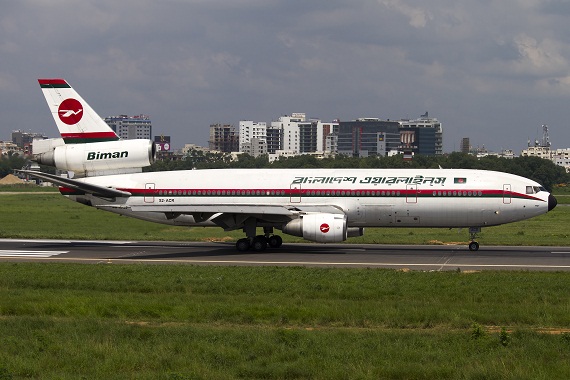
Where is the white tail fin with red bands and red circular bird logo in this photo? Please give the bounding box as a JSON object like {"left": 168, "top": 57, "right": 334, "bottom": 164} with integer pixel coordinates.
{"left": 38, "top": 79, "right": 119, "bottom": 144}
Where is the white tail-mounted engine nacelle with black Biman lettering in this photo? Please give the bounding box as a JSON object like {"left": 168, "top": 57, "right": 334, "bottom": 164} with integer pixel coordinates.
{"left": 34, "top": 140, "right": 156, "bottom": 175}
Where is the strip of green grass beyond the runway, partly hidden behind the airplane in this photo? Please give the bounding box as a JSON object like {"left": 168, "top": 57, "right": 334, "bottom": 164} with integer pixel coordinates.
{"left": 0, "top": 194, "right": 570, "bottom": 246}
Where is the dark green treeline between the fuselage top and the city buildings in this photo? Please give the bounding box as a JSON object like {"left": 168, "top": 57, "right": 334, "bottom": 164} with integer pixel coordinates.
{"left": 148, "top": 150, "right": 570, "bottom": 190}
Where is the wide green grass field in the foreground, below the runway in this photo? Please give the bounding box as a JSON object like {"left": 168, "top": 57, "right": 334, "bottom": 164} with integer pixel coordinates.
{"left": 0, "top": 263, "right": 570, "bottom": 379}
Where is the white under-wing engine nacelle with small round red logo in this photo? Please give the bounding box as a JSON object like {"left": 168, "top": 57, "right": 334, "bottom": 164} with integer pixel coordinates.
{"left": 282, "top": 213, "right": 347, "bottom": 243}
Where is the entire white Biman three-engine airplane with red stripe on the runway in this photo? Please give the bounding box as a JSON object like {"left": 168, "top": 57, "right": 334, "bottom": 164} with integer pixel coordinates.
{"left": 25, "top": 79, "right": 557, "bottom": 251}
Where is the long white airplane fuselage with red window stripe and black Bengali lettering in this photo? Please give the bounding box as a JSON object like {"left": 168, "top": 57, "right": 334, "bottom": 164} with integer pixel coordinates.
{"left": 62, "top": 169, "right": 549, "bottom": 227}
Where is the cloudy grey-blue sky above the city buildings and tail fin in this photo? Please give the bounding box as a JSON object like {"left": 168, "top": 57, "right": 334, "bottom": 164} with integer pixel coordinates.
{"left": 0, "top": 0, "right": 570, "bottom": 153}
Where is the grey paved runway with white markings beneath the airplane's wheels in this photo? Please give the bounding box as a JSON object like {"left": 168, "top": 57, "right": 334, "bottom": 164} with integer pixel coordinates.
{"left": 0, "top": 239, "right": 570, "bottom": 271}
